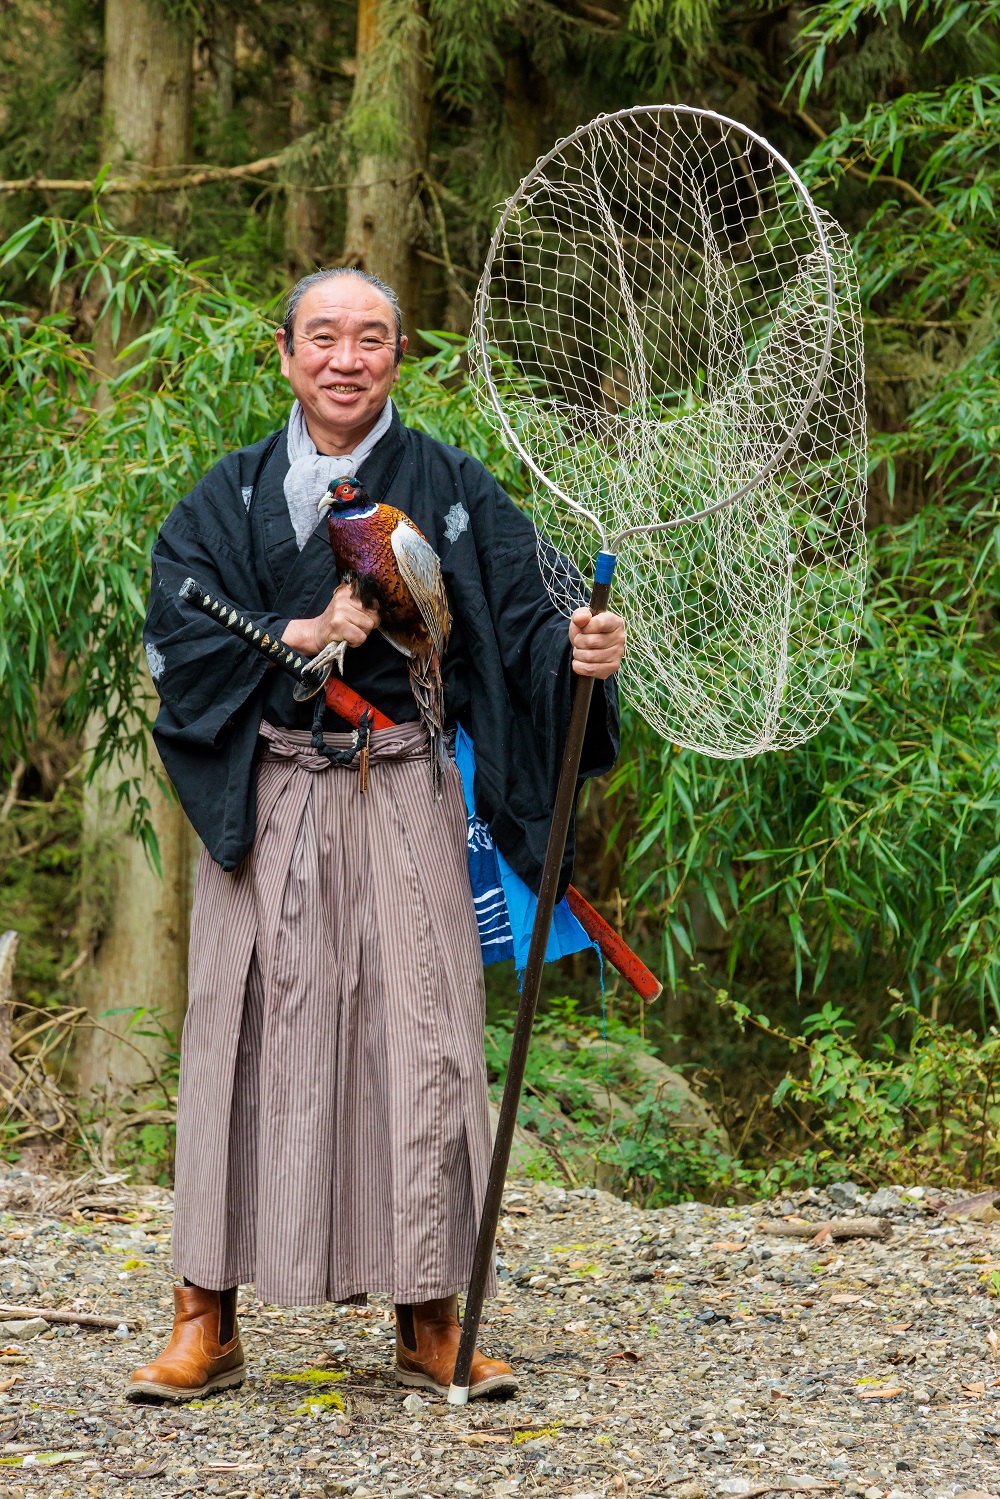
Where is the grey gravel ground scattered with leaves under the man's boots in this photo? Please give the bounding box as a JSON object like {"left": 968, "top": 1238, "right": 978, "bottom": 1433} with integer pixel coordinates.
{"left": 0, "top": 1181, "right": 1000, "bottom": 1499}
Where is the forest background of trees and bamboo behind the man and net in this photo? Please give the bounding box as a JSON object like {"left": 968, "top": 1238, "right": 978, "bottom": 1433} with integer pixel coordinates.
{"left": 0, "top": 0, "right": 1000, "bottom": 1202}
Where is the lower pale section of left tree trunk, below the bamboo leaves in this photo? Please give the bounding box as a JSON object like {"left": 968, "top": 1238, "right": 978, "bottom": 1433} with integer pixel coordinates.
{"left": 75, "top": 669, "right": 198, "bottom": 1102}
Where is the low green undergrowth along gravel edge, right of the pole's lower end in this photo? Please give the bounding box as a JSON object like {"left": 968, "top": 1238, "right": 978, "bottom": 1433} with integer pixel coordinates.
{"left": 487, "top": 991, "right": 1000, "bottom": 1207}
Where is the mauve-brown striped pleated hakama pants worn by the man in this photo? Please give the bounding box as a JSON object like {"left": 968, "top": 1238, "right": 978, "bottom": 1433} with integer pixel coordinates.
{"left": 174, "top": 724, "right": 493, "bottom": 1306}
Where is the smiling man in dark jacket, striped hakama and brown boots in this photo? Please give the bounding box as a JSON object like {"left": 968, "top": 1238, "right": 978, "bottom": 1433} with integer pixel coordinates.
{"left": 129, "top": 270, "right": 624, "bottom": 1400}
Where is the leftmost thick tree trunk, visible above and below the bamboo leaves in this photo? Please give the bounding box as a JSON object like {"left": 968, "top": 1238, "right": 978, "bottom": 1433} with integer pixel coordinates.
{"left": 75, "top": 0, "right": 195, "bottom": 1100}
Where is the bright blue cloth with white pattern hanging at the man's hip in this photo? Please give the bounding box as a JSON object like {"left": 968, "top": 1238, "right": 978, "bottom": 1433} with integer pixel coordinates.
{"left": 454, "top": 724, "right": 597, "bottom": 973}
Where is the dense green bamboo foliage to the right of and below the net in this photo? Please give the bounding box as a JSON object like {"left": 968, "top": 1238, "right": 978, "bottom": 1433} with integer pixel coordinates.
{"left": 612, "top": 0, "right": 1000, "bottom": 1024}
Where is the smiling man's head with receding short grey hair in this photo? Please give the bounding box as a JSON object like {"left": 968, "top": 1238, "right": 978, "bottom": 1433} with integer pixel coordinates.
{"left": 276, "top": 276, "right": 406, "bottom": 456}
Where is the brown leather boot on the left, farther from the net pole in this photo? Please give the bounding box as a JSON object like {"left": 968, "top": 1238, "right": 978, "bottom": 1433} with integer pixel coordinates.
{"left": 127, "top": 1286, "right": 246, "bottom": 1400}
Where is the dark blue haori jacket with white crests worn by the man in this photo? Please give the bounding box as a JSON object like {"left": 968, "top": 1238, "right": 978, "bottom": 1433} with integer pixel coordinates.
{"left": 144, "top": 412, "right": 619, "bottom": 893}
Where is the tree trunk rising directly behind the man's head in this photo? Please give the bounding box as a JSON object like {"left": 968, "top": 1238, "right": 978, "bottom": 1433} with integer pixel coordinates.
{"left": 343, "top": 0, "right": 432, "bottom": 337}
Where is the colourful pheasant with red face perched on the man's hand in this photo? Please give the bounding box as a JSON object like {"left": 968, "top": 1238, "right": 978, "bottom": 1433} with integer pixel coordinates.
{"left": 295, "top": 478, "right": 451, "bottom": 799}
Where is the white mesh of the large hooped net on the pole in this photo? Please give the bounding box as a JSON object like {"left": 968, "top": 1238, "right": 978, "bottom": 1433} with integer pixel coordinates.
{"left": 474, "top": 106, "right": 865, "bottom": 757}
